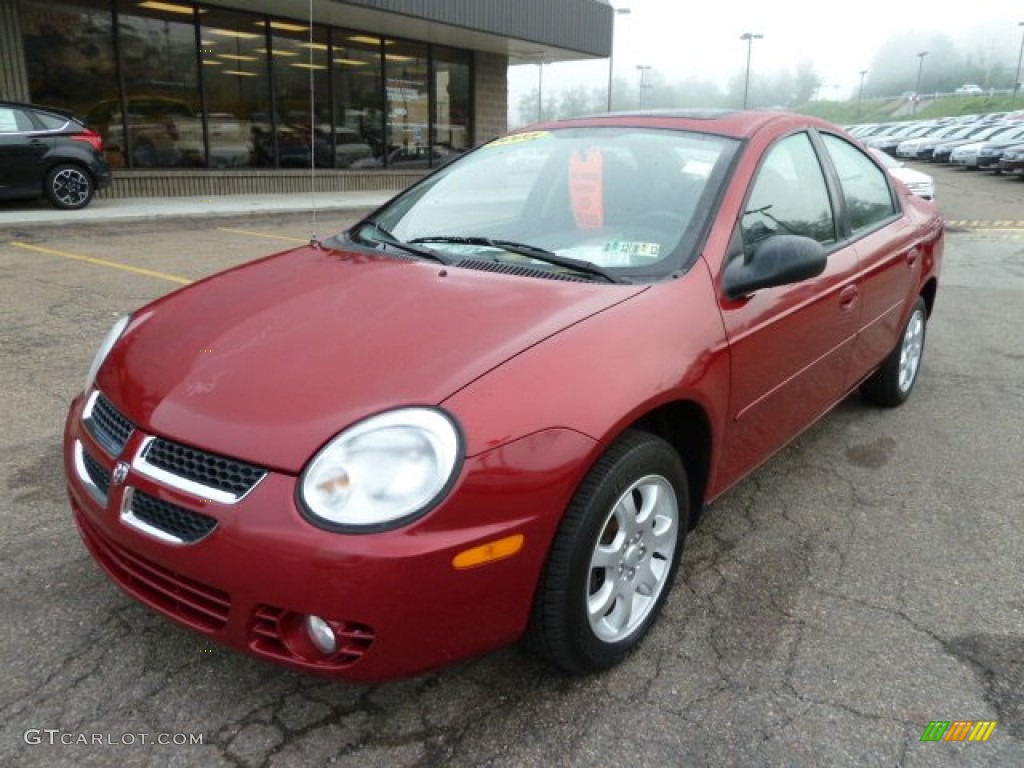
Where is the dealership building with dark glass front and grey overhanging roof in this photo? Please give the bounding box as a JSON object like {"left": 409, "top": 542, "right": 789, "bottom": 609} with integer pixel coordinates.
{"left": 0, "top": 0, "right": 614, "bottom": 197}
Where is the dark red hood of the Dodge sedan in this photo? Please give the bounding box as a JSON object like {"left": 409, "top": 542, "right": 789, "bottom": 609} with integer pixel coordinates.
{"left": 97, "top": 247, "right": 644, "bottom": 472}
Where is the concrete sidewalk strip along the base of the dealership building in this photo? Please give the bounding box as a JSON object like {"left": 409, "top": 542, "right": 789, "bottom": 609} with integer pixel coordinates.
{"left": 0, "top": 190, "right": 398, "bottom": 227}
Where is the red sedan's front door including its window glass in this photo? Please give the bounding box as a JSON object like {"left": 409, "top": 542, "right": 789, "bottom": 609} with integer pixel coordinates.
{"left": 715, "top": 133, "right": 860, "bottom": 487}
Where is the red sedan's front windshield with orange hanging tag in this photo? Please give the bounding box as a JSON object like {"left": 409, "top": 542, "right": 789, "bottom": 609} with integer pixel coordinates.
{"left": 350, "top": 127, "right": 738, "bottom": 282}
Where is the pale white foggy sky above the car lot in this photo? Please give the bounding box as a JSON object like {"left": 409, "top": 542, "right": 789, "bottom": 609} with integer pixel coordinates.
{"left": 509, "top": 0, "right": 1024, "bottom": 118}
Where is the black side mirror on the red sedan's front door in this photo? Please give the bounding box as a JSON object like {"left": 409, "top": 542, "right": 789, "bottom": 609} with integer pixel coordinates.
{"left": 722, "top": 234, "right": 827, "bottom": 299}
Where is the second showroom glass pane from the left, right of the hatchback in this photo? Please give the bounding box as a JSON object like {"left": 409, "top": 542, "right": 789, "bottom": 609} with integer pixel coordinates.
{"left": 109, "top": 0, "right": 206, "bottom": 168}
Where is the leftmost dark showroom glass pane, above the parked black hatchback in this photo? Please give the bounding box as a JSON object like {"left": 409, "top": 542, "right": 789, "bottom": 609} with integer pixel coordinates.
{"left": 19, "top": 0, "right": 117, "bottom": 166}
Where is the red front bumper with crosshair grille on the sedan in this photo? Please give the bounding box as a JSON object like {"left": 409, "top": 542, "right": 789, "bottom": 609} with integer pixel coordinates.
{"left": 65, "top": 391, "right": 596, "bottom": 681}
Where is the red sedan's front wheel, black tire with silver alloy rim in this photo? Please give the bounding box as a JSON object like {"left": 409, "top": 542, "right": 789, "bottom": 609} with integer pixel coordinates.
{"left": 525, "top": 432, "right": 689, "bottom": 674}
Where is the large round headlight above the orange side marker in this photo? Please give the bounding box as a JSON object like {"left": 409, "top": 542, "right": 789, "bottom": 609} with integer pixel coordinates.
{"left": 299, "top": 408, "right": 461, "bottom": 531}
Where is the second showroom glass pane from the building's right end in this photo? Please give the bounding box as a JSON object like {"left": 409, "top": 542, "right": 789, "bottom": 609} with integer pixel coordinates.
{"left": 384, "top": 40, "right": 430, "bottom": 168}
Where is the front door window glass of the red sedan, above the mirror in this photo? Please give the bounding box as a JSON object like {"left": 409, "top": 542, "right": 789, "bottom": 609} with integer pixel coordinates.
{"left": 741, "top": 133, "right": 836, "bottom": 253}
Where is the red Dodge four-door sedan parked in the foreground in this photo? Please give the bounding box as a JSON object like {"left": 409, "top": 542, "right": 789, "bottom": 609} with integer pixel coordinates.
{"left": 65, "top": 112, "right": 943, "bottom": 680}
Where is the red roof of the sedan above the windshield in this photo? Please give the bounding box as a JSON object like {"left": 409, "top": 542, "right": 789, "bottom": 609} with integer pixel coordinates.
{"left": 521, "top": 110, "right": 842, "bottom": 138}
